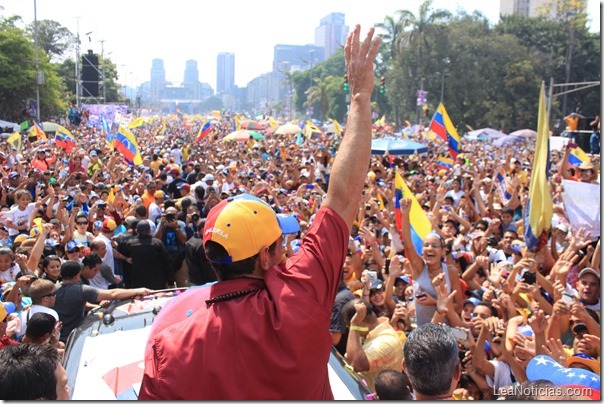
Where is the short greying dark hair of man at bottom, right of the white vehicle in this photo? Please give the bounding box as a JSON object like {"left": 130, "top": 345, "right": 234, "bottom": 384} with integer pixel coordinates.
{"left": 403, "top": 323, "right": 459, "bottom": 396}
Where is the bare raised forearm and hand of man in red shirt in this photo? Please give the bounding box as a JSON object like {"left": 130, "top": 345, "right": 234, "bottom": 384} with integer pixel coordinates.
{"left": 323, "top": 25, "right": 380, "bottom": 229}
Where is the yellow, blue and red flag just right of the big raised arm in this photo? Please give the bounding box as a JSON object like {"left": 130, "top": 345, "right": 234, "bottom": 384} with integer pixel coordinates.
{"left": 394, "top": 172, "right": 432, "bottom": 255}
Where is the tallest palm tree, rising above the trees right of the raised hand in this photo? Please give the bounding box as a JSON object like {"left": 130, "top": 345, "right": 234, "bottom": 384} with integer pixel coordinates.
{"left": 397, "top": 0, "right": 451, "bottom": 78}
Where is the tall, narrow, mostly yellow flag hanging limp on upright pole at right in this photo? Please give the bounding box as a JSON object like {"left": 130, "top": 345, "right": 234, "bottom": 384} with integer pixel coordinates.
{"left": 524, "top": 82, "right": 553, "bottom": 252}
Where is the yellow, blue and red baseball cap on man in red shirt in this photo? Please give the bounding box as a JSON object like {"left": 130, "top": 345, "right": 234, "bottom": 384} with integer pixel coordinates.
{"left": 203, "top": 194, "right": 300, "bottom": 264}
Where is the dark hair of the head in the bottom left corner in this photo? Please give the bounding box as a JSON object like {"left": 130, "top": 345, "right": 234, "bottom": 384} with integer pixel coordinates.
{"left": 0, "top": 344, "right": 60, "bottom": 400}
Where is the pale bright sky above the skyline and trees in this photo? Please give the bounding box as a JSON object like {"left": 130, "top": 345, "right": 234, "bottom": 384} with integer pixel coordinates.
{"left": 0, "top": 0, "right": 600, "bottom": 89}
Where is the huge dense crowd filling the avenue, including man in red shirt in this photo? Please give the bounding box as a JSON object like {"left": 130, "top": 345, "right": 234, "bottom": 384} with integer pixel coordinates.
{"left": 0, "top": 28, "right": 601, "bottom": 400}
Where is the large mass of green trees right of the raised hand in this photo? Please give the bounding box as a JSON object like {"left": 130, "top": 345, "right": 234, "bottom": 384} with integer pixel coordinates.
{"left": 373, "top": 0, "right": 601, "bottom": 133}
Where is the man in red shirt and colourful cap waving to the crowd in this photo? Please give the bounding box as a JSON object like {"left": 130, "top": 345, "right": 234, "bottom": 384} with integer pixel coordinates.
{"left": 139, "top": 25, "right": 380, "bottom": 400}
